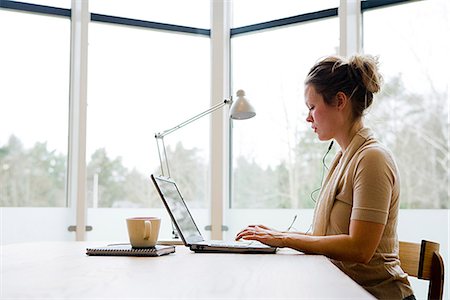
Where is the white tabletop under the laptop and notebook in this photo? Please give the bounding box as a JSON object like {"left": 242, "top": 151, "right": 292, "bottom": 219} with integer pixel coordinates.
{"left": 0, "top": 242, "right": 373, "bottom": 299}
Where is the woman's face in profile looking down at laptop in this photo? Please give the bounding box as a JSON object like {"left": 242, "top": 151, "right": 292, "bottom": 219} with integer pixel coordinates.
{"left": 305, "top": 85, "right": 339, "bottom": 141}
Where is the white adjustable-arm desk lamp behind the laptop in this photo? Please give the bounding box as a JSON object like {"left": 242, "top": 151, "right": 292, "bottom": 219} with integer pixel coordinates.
{"left": 155, "top": 90, "right": 256, "bottom": 178}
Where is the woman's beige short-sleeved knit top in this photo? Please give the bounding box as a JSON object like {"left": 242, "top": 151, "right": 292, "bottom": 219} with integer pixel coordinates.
{"left": 313, "top": 128, "right": 413, "bottom": 299}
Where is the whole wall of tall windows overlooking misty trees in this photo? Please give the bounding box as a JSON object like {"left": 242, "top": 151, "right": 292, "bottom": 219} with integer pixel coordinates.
{"left": 0, "top": 0, "right": 449, "bottom": 251}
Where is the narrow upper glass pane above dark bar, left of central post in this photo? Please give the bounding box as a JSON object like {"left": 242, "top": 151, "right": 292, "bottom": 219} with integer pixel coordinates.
{"left": 89, "top": 0, "right": 210, "bottom": 29}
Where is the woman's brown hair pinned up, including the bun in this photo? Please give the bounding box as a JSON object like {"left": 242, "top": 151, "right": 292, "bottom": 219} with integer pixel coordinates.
{"left": 305, "top": 55, "right": 382, "bottom": 118}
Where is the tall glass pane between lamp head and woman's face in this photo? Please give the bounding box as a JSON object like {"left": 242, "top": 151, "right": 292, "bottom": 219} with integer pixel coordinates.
{"left": 232, "top": 18, "right": 339, "bottom": 208}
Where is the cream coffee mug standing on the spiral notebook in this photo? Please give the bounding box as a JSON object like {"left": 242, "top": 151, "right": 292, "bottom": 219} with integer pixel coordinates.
{"left": 127, "top": 217, "right": 161, "bottom": 248}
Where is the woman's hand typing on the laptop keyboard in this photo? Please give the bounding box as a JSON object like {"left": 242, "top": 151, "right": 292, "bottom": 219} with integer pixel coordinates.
{"left": 236, "top": 225, "right": 286, "bottom": 247}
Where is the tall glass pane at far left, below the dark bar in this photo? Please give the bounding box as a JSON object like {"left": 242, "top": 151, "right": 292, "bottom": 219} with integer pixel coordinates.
{"left": 0, "top": 10, "right": 70, "bottom": 207}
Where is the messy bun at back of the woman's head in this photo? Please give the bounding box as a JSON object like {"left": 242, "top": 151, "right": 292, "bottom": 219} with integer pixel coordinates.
{"left": 348, "top": 55, "right": 382, "bottom": 93}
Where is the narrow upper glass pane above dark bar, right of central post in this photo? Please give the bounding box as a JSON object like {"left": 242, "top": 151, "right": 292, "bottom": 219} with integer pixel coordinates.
{"left": 232, "top": 0, "right": 339, "bottom": 27}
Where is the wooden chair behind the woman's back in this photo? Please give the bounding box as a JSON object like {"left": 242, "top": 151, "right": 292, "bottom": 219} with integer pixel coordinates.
{"left": 399, "top": 240, "right": 444, "bottom": 300}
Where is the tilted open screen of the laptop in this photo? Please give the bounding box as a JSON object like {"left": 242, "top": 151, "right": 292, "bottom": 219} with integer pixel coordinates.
{"left": 152, "top": 175, "right": 203, "bottom": 245}
